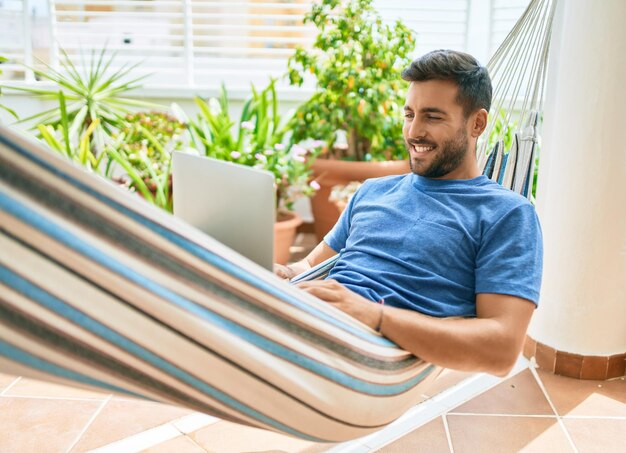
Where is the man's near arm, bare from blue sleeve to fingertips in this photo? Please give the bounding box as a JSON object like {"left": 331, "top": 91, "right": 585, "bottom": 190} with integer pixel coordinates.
{"left": 298, "top": 280, "right": 535, "bottom": 376}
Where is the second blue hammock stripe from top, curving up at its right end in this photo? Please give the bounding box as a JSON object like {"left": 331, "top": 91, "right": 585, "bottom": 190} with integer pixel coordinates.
{"left": 0, "top": 193, "right": 422, "bottom": 396}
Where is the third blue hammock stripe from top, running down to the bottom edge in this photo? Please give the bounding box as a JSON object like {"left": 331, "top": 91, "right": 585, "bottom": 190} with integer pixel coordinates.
{"left": 0, "top": 265, "right": 323, "bottom": 442}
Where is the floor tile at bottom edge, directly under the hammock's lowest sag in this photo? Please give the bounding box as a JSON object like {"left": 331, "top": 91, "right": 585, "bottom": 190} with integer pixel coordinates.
{"left": 188, "top": 422, "right": 336, "bottom": 453}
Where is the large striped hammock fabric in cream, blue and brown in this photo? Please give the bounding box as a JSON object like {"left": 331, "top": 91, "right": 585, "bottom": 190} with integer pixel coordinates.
{"left": 0, "top": 128, "right": 438, "bottom": 442}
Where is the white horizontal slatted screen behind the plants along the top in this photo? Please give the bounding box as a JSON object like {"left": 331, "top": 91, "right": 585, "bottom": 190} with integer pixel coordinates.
{"left": 0, "top": 0, "right": 528, "bottom": 90}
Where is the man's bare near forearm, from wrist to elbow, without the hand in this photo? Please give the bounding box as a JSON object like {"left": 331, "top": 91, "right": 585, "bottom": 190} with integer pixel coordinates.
{"left": 380, "top": 307, "right": 522, "bottom": 375}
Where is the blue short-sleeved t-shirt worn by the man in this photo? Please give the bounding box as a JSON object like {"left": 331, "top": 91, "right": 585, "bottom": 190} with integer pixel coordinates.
{"left": 324, "top": 174, "right": 543, "bottom": 317}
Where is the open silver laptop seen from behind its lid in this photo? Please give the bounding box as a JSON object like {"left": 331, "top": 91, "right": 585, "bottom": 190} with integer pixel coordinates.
{"left": 172, "top": 152, "right": 276, "bottom": 270}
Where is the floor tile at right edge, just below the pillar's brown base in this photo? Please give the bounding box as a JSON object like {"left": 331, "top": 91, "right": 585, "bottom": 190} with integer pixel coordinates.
{"left": 538, "top": 370, "right": 626, "bottom": 417}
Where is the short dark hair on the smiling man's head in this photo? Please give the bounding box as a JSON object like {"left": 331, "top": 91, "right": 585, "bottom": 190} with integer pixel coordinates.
{"left": 402, "top": 49, "right": 491, "bottom": 117}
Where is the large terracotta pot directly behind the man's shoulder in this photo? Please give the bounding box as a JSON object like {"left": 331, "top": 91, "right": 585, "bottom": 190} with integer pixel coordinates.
{"left": 311, "top": 159, "right": 411, "bottom": 241}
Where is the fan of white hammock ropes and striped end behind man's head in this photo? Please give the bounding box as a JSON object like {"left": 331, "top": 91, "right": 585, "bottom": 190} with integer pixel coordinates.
{"left": 477, "top": 0, "right": 556, "bottom": 198}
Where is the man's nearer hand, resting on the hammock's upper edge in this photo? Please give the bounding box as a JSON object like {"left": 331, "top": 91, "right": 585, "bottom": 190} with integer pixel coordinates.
{"left": 297, "top": 280, "right": 383, "bottom": 330}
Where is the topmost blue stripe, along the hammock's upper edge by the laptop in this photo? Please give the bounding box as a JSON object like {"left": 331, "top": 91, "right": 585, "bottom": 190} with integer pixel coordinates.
{"left": 0, "top": 135, "right": 397, "bottom": 349}
